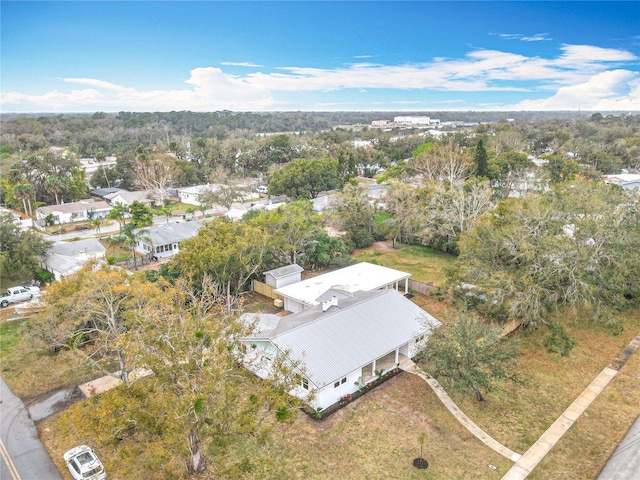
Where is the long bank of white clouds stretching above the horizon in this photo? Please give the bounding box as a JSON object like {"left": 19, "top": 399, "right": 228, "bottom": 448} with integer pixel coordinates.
{"left": 0, "top": 42, "right": 640, "bottom": 112}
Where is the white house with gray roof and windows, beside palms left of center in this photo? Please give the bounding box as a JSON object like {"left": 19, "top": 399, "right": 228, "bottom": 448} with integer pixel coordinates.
{"left": 135, "top": 220, "right": 203, "bottom": 258}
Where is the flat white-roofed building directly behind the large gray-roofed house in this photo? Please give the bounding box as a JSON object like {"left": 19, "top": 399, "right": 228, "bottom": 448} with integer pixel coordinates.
{"left": 274, "top": 262, "right": 411, "bottom": 312}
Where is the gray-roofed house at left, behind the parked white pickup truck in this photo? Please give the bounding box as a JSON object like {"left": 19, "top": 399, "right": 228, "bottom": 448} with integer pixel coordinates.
{"left": 40, "top": 238, "right": 106, "bottom": 281}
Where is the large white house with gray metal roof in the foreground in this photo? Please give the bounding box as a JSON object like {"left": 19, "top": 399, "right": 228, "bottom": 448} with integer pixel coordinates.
{"left": 241, "top": 290, "right": 440, "bottom": 410}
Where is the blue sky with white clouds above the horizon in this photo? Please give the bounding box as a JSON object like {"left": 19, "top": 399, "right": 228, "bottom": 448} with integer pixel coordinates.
{"left": 0, "top": 0, "right": 640, "bottom": 112}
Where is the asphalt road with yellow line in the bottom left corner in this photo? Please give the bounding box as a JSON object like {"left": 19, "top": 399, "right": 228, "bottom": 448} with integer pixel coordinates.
{"left": 0, "top": 377, "right": 62, "bottom": 480}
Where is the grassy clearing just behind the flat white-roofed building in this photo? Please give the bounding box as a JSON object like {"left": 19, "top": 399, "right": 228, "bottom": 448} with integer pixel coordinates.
{"left": 353, "top": 242, "right": 456, "bottom": 285}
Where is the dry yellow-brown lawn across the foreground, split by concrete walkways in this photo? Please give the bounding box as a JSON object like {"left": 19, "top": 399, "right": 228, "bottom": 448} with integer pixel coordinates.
{"left": 0, "top": 296, "right": 624, "bottom": 480}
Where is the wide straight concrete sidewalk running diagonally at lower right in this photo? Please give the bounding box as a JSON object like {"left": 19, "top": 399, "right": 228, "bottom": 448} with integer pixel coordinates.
{"left": 502, "top": 334, "right": 640, "bottom": 480}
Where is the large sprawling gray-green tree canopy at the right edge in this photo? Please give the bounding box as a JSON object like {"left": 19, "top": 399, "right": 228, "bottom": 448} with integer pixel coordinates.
{"left": 452, "top": 181, "right": 640, "bottom": 323}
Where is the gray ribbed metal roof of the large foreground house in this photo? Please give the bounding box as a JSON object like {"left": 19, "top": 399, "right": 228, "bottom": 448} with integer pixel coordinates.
{"left": 248, "top": 290, "right": 440, "bottom": 388}
